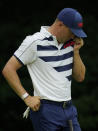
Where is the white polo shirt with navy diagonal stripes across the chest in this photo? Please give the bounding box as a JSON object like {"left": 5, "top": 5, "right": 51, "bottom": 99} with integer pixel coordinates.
{"left": 14, "top": 26, "right": 73, "bottom": 101}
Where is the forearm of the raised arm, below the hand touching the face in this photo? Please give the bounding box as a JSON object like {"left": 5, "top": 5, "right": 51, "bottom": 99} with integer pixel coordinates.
{"left": 73, "top": 50, "right": 85, "bottom": 82}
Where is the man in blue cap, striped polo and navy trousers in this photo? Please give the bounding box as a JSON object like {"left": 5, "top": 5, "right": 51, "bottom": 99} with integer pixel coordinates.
{"left": 3, "top": 8, "right": 87, "bottom": 131}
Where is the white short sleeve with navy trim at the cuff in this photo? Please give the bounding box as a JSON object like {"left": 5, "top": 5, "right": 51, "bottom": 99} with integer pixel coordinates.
{"left": 14, "top": 36, "right": 37, "bottom": 65}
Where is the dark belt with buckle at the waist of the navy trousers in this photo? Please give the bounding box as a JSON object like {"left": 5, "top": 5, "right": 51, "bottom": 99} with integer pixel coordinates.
{"left": 41, "top": 99, "right": 72, "bottom": 108}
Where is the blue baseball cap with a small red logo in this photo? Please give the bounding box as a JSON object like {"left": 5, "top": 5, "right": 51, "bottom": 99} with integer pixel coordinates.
{"left": 57, "top": 8, "right": 87, "bottom": 37}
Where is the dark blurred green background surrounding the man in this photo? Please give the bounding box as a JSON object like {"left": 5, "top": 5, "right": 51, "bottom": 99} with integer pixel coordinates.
{"left": 0, "top": 0, "right": 98, "bottom": 131}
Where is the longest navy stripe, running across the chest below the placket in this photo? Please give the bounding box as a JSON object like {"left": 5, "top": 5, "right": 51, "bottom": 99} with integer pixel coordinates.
{"left": 39, "top": 51, "right": 73, "bottom": 62}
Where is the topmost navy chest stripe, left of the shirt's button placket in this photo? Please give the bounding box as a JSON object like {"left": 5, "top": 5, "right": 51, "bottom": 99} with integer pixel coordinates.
{"left": 37, "top": 45, "right": 58, "bottom": 51}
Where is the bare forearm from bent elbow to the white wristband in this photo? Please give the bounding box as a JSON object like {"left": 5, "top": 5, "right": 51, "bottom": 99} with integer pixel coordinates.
{"left": 2, "top": 65, "right": 26, "bottom": 98}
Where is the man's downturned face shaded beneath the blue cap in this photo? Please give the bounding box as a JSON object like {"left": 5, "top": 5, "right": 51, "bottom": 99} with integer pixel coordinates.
{"left": 60, "top": 24, "right": 75, "bottom": 43}
